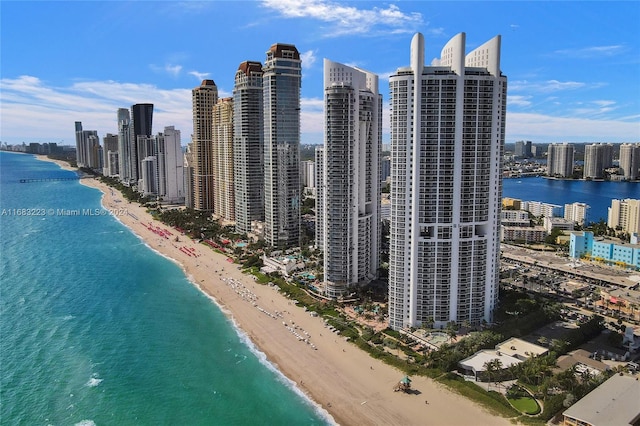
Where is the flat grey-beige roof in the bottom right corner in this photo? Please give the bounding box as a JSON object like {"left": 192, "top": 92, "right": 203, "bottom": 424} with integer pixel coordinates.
{"left": 563, "top": 374, "right": 640, "bottom": 426}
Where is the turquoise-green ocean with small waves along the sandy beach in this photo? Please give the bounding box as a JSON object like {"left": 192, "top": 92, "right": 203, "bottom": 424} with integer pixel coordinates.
{"left": 0, "top": 152, "right": 333, "bottom": 426}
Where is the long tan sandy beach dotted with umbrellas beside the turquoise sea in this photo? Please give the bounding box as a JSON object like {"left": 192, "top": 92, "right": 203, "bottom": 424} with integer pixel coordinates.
{"left": 38, "top": 156, "right": 511, "bottom": 425}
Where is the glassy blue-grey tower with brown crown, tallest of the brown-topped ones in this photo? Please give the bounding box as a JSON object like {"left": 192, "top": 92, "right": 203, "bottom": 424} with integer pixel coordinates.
{"left": 263, "top": 43, "right": 302, "bottom": 248}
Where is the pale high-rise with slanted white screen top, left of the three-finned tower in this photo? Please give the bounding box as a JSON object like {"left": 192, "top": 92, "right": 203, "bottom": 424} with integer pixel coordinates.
{"left": 316, "top": 59, "right": 382, "bottom": 298}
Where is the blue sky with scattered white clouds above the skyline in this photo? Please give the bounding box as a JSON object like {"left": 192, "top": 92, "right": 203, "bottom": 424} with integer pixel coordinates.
{"left": 0, "top": 0, "right": 640, "bottom": 145}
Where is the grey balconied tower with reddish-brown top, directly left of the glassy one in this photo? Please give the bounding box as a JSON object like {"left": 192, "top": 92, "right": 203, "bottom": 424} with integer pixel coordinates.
{"left": 233, "top": 61, "right": 264, "bottom": 233}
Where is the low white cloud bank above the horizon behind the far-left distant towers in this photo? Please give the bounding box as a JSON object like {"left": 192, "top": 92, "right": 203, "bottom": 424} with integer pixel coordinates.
{"left": 0, "top": 76, "right": 192, "bottom": 145}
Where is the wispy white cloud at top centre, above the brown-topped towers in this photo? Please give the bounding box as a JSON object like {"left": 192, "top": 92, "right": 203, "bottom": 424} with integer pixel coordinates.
{"left": 262, "top": 0, "right": 424, "bottom": 37}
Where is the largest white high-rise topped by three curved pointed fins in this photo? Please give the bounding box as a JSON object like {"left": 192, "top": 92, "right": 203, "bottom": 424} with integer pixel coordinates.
{"left": 389, "top": 33, "right": 507, "bottom": 329}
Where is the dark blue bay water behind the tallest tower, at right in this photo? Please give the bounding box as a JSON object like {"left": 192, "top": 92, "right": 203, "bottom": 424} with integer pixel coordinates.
{"left": 502, "top": 177, "right": 640, "bottom": 222}
